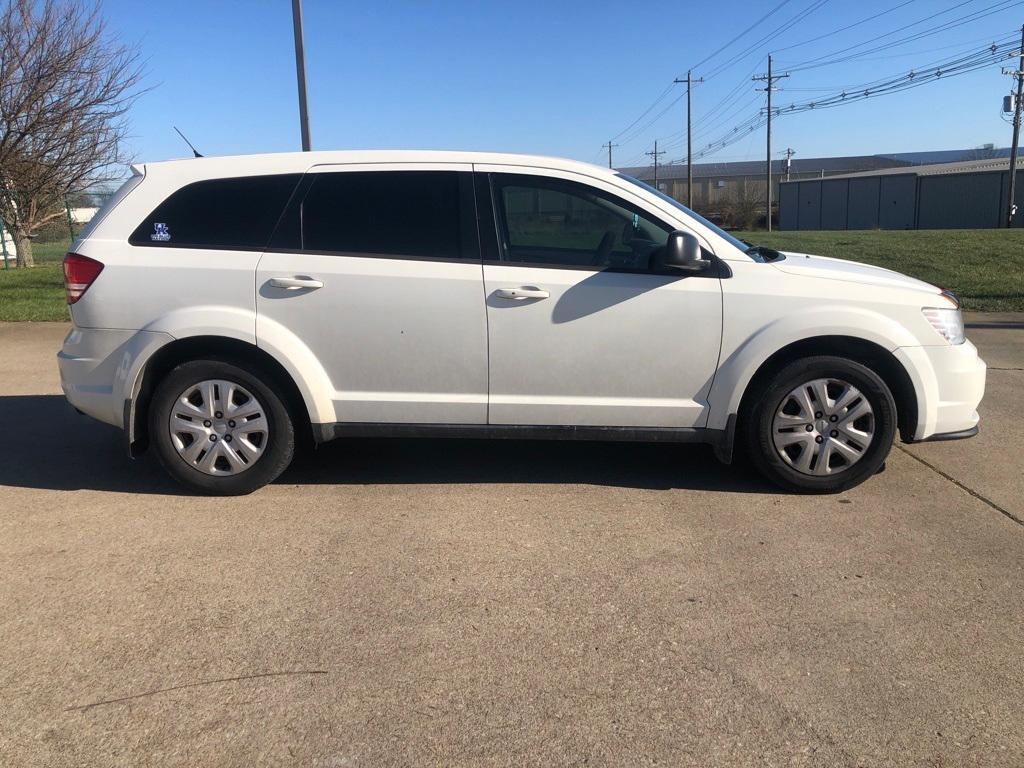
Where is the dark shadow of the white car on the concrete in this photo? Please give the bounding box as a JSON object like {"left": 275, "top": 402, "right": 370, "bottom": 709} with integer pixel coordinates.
{"left": 0, "top": 395, "right": 777, "bottom": 495}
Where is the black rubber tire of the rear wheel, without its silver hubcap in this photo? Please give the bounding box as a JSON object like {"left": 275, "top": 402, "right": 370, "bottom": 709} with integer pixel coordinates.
{"left": 148, "top": 359, "right": 295, "bottom": 496}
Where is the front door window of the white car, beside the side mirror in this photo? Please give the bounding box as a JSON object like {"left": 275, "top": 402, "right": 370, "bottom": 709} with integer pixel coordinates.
{"left": 493, "top": 174, "right": 671, "bottom": 270}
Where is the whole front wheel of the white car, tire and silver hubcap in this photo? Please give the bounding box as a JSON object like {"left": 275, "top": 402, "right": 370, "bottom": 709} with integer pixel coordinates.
{"left": 742, "top": 356, "right": 896, "bottom": 494}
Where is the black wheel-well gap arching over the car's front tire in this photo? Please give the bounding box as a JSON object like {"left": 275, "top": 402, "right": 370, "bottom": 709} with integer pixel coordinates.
{"left": 736, "top": 336, "right": 919, "bottom": 440}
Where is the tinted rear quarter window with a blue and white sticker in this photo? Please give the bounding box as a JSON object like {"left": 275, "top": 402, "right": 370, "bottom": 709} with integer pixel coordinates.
{"left": 129, "top": 173, "right": 301, "bottom": 250}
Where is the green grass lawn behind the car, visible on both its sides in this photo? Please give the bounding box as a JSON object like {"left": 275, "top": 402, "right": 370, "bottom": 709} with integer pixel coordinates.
{"left": 0, "top": 229, "right": 1024, "bottom": 321}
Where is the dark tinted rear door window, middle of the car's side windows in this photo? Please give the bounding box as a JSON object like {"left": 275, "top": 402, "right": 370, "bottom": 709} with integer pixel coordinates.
{"left": 300, "top": 171, "right": 476, "bottom": 259}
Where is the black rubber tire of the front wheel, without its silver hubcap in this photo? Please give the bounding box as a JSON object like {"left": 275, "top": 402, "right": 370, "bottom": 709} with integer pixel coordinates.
{"left": 745, "top": 356, "right": 896, "bottom": 494}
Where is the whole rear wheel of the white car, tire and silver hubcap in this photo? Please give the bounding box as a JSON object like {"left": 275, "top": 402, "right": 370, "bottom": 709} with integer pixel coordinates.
{"left": 148, "top": 359, "right": 295, "bottom": 496}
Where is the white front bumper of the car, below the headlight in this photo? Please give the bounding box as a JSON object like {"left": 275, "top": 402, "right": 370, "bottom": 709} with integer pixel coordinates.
{"left": 895, "top": 341, "right": 986, "bottom": 442}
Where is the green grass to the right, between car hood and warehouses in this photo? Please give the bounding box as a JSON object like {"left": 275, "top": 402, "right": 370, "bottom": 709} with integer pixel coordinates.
{"left": 738, "top": 229, "right": 1024, "bottom": 312}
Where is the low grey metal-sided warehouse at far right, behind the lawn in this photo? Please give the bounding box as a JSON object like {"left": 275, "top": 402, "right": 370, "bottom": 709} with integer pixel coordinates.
{"left": 778, "top": 159, "right": 1024, "bottom": 229}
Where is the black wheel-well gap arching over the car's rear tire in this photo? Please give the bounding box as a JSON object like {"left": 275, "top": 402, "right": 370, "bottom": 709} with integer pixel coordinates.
{"left": 124, "top": 335, "right": 312, "bottom": 457}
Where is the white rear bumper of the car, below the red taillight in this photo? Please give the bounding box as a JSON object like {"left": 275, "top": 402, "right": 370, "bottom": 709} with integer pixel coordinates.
{"left": 57, "top": 328, "right": 172, "bottom": 428}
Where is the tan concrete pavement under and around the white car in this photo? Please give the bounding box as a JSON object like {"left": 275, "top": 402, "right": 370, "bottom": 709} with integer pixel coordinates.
{"left": 0, "top": 315, "right": 1024, "bottom": 767}
